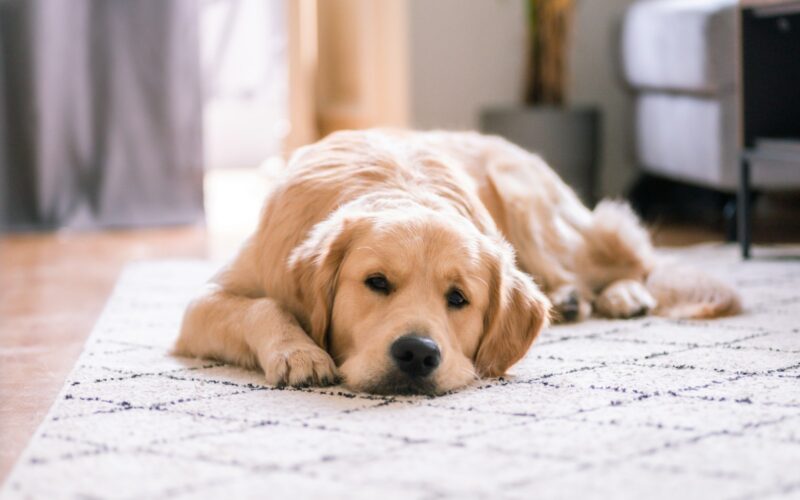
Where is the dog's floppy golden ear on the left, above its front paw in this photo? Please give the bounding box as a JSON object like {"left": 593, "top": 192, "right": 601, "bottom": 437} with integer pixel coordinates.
{"left": 288, "top": 216, "right": 366, "bottom": 349}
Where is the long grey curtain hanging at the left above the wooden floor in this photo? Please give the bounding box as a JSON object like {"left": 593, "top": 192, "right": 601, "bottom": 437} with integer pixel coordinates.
{"left": 0, "top": 0, "right": 203, "bottom": 230}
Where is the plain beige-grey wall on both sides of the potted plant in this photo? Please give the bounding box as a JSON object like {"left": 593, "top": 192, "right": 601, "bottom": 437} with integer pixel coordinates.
{"left": 408, "top": 0, "right": 635, "bottom": 195}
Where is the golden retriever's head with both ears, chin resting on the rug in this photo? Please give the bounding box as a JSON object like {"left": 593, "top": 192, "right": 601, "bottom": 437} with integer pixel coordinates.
{"left": 289, "top": 202, "right": 549, "bottom": 394}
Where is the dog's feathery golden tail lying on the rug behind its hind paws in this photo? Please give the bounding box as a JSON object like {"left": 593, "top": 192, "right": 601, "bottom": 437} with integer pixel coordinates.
{"left": 646, "top": 263, "right": 742, "bottom": 319}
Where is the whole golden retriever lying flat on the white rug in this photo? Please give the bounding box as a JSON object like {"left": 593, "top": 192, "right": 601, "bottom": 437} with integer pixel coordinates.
{"left": 175, "top": 130, "right": 739, "bottom": 395}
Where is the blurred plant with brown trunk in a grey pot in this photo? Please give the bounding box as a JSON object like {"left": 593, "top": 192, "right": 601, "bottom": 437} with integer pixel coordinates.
{"left": 480, "top": 0, "right": 599, "bottom": 204}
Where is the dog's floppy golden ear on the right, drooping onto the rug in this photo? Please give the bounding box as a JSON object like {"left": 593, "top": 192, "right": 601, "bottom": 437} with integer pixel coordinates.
{"left": 475, "top": 244, "right": 550, "bottom": 377}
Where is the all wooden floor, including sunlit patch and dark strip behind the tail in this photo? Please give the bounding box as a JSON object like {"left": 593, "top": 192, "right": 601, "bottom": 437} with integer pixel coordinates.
{"left": 0, "top": 172, "right": 788, "bottom": 482}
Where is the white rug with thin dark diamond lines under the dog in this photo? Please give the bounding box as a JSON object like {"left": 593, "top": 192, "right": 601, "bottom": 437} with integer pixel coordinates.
{"left": 0, "top": 247, "right": 800, "bottom": 499}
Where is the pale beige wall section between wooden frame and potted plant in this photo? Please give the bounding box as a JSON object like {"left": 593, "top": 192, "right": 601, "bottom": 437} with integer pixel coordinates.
{"left": 408, "top": 0, "right": 526, "bottom": 129}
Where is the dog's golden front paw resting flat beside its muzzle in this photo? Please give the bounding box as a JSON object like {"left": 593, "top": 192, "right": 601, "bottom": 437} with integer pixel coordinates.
{"left": 259, "top": 344, "right": 339, "bottom": 387}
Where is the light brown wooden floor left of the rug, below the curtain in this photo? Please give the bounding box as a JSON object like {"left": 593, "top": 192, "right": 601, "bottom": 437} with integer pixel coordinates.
{"left": 0, "top": 228, "right": 206, "bottom": 479}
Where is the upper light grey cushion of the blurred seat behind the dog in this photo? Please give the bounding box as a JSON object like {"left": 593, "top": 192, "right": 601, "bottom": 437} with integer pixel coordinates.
{"left": 622, "top": 0, "right": 738, "bottom": 93}
